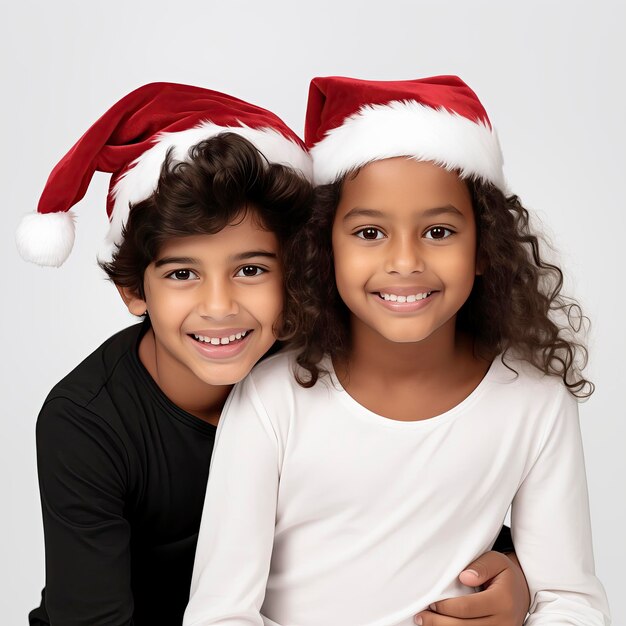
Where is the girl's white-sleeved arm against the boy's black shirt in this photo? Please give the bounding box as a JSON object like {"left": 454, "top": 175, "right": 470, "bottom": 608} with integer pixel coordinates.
{"left": 183, "top": 378, "right": 280, "bottom": 626}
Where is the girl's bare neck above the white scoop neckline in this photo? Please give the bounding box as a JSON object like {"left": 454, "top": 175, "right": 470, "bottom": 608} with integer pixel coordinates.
{"left": 334, "top": 319, "right": 489, "bottom": 421}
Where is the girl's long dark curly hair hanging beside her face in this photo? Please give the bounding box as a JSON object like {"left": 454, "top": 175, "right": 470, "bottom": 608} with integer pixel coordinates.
{"left": 287, "top": 172, "right": 594, "bottom": 398}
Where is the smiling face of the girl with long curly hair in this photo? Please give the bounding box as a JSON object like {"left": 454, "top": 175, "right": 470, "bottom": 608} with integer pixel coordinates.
{"left": 332, "top": 158, "right": 477, "bottom": 343}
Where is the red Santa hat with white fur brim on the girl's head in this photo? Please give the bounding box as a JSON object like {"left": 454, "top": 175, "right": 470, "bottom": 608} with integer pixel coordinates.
{"left": 305, "top": 76, "right": 505, "bottom": 189}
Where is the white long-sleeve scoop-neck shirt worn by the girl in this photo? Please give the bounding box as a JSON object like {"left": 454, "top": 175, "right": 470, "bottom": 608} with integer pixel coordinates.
{"left": 184, "top": 353, "right": 609, "bottom": 626}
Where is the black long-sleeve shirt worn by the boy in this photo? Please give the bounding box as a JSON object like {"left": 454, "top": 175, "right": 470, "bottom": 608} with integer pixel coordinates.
{"left": 30, "top": 324, "right": 215, "bottom": 626}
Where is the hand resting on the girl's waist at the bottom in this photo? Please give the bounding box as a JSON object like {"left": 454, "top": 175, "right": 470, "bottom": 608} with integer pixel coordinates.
{"left": 415, "top": 552, "right": 530, "bottom": 626}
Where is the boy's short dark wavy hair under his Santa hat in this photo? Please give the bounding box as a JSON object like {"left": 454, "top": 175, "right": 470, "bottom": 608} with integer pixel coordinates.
{"left": 100, "top": 132, "right": 313, "bottom": 333}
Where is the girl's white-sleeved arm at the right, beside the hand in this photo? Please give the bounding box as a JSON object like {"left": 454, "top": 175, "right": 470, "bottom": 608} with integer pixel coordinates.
{"left": 511, "top": 387, "right": 610, "bottom": 626}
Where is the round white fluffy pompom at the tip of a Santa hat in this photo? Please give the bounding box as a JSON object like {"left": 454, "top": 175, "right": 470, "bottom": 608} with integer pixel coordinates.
{"left": 15, "top": 211, "right": 74, "bottom": 267}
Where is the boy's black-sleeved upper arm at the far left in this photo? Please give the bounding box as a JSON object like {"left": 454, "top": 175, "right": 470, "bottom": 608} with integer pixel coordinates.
{"left": 37, "top": 398, "right": 133, "bottom": 626}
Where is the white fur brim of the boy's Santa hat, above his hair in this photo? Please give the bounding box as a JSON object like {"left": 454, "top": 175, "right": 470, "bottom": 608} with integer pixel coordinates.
{"left": 107, "top": 122, "right": 313, "bottom": 243}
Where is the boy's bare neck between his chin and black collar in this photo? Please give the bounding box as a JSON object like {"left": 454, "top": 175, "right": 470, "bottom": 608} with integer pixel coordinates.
{"left": 139, "top": 328, "right": 233, "bottom": 426}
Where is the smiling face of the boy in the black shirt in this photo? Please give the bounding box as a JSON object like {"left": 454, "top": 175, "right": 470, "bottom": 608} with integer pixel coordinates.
{"left": 129, "top": 211, "right": 283, "bottom": 385}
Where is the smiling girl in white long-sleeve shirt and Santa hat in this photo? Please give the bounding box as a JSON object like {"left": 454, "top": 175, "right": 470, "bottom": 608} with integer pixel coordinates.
{"left": 184, "top": 77, "right": 609, "bottom": 626}
